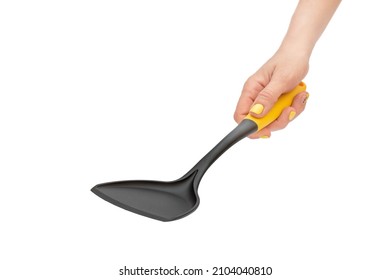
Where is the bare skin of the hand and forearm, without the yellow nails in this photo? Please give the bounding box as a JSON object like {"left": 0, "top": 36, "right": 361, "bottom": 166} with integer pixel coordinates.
{"left": 234, "top": 0, "right": 341, "bottom": 139}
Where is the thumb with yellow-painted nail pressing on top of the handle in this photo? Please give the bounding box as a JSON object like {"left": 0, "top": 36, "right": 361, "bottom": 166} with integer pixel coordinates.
{"left": 250, "top": 79, "right": 289, "bottom": 118}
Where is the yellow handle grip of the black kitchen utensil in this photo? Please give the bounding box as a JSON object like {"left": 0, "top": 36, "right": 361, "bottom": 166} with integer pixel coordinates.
{"left": 245, "top": 82, "right": 307, "bottom": 131}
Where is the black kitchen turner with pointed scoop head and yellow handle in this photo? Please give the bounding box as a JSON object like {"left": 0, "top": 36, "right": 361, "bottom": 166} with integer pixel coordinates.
{"left": 91, "top": 82, "right": 306, "bottom": 221}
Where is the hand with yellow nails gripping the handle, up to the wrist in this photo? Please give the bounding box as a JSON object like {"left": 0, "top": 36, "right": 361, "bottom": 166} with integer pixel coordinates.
{"left": 234, "top": 50, "right": 309, "bottom": 139}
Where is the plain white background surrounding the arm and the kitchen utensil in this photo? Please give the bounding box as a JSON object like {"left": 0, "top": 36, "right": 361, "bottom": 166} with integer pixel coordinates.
{"left": 0, "top": 0, "right": 391, "bottom": 280}
